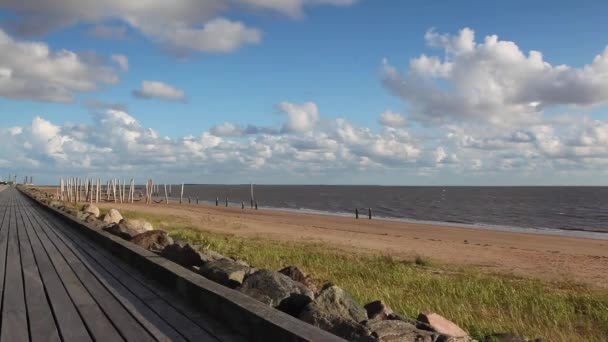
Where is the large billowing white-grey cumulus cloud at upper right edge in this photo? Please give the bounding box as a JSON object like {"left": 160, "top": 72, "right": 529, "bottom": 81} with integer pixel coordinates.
{"left": 383, "top": 28, "right": 608, "bottom": 125}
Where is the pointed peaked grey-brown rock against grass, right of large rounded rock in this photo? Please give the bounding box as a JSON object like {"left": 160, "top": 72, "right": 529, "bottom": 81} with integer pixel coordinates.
{"left": 300, "top": 284, "right": 367, "bottom": 323}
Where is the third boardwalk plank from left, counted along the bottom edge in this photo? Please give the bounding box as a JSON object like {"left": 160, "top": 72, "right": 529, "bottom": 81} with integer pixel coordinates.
{"left": 18, "top": 198, "right": 92, "bottom": 341}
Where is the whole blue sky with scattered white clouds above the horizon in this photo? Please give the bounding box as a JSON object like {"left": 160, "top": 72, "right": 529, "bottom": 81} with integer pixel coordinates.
{"left": 0, "top": 0, "right": 608, "bottom": 185}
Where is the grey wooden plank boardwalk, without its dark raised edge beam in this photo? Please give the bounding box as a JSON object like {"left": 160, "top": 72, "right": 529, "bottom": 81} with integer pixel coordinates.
{"left": 0, "top": 188, "right": 243, "bottom": 342}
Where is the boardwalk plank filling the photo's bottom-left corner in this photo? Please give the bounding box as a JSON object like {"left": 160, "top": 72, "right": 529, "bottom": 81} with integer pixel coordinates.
{"left": 0, "top": 192, "right": 29, "bottom": 342}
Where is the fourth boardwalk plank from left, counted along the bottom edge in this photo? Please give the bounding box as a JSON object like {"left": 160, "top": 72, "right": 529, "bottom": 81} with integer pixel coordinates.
{"left": 22, "top": 199, "right": 123, "bottom": 341}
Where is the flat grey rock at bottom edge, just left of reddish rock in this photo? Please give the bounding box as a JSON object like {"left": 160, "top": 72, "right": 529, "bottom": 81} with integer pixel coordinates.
{"left": 367, "top": 320, "right": 436, "bottom": 342}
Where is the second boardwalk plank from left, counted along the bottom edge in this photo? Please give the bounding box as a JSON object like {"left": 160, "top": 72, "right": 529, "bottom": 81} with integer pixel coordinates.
{"left": 17, "top": 199, "right": 61, "bottom": 341}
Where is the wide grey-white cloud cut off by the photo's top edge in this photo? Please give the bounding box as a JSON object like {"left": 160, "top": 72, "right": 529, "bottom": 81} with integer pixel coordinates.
{"left": 0, "top": 0, "right": 354, "bottom": 54}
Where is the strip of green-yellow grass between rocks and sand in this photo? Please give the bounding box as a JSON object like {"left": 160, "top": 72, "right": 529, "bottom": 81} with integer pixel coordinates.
{"left": 105, "top": 211, "right": 608, "bottom": 341}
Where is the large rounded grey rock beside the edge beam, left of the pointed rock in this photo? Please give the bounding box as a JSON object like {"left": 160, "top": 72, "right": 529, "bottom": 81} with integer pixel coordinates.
{"left": 238, "top": 270, "right": 314, "bottom": 317}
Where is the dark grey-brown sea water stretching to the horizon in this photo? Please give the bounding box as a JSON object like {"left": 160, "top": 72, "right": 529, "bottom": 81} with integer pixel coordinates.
{"left": 172, "top": 184, "right": 608, "bottom": 237}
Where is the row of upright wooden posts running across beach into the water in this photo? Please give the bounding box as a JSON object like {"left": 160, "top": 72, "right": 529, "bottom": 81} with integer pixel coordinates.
{"left": 57, "top": 177, "right": 372, "bottom": 220}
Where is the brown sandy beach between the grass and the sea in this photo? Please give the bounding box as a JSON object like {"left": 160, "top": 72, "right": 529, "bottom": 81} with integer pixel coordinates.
{"left": 84, "top": 199, "right": 608, "bottom": 288}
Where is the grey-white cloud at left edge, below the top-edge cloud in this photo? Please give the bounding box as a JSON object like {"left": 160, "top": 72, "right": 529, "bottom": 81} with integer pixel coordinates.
{"left": 0, "top": 29, "right": 119, "bottom": 102}
